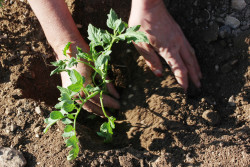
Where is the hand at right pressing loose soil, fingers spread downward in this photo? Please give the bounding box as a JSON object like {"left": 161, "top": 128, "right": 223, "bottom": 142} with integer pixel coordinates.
{"left": 129, "top": 0, "right": 202, "bottom": 91}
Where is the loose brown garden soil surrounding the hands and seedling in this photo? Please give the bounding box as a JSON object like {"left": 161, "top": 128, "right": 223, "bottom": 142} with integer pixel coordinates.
{"left": 0, "top": 0, "right": 250, "bottom": 167}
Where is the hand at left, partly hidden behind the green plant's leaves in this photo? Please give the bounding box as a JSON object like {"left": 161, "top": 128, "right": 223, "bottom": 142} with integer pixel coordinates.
{"left": 58, "top": 44, "right": 120, "bottom": 117}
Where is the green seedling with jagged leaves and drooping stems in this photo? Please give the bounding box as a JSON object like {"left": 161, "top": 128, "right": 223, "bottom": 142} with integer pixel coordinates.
{"left": 44, "top": 9, "right": 148, "bottom": 160}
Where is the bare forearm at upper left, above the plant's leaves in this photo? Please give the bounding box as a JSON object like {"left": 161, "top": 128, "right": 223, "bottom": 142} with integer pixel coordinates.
{"left": 28, "top": 0, "right": 88, "bottom": 58}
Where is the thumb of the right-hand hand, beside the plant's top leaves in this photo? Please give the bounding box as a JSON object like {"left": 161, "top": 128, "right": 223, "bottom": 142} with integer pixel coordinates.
{"left": 134, "top": 42, "right": 162, "bottom": 77}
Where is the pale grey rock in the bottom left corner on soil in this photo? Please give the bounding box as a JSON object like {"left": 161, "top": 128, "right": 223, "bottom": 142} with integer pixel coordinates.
{"left": 0, "top": 147, "right": 27, "bottom": 167}
